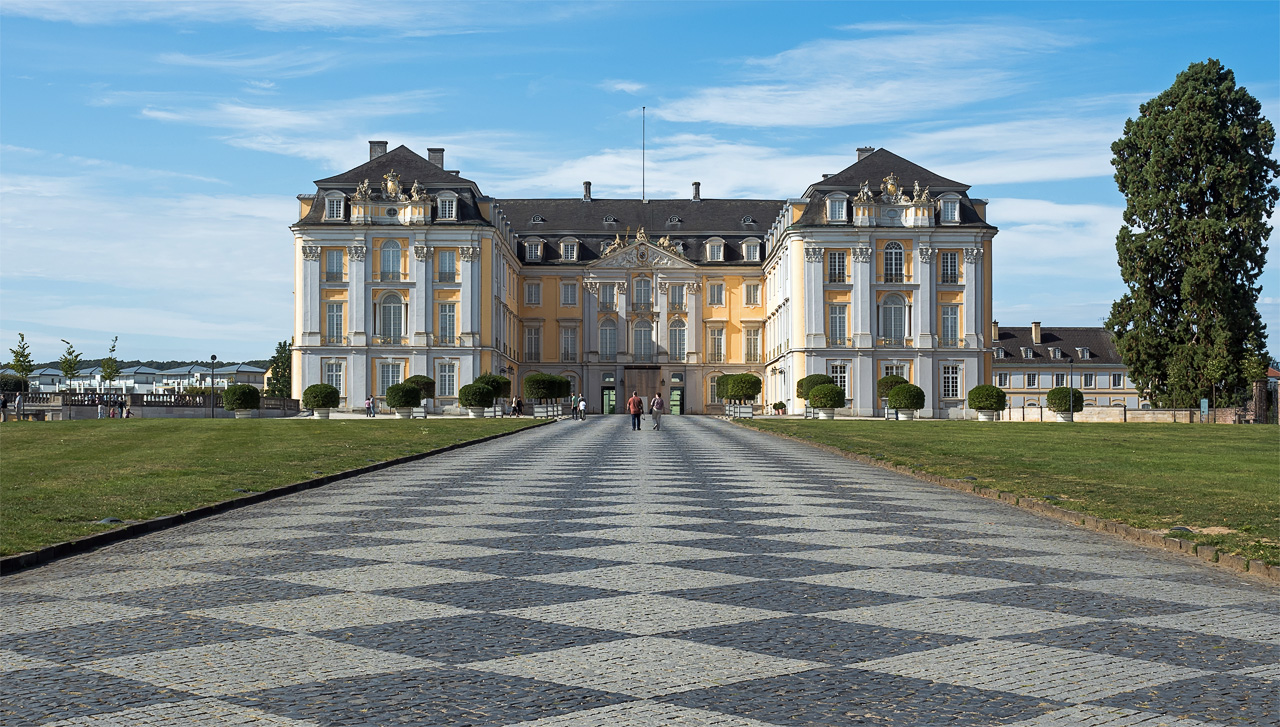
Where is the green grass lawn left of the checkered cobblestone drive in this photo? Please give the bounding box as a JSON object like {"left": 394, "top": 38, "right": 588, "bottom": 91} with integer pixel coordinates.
{"left": 0, "top": 419, "right": 535, "bottom": 555}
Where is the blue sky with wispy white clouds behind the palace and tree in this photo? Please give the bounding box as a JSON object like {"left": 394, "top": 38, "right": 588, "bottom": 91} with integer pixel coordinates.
{"left": 0, "top": 0, "right": 1280, "bottom": 360}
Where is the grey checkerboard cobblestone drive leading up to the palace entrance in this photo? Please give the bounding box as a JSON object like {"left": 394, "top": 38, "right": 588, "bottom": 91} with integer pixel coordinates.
{"left": 0, "top": 417, "right": 1280, "bottom": 727}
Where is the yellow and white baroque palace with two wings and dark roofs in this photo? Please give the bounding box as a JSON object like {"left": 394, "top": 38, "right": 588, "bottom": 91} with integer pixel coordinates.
{"left": 291, "top": 142, "right": 997, "bottom": 417}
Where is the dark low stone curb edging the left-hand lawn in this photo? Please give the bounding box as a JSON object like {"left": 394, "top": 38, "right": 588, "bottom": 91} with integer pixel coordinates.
{"left": 0, "top": 419, "right": 559, "bottom": 577}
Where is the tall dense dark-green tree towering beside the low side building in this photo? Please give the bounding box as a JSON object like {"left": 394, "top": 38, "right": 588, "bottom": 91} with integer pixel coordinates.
{"left": 1107, "top": 60, "right": 1280, "bottom": 407}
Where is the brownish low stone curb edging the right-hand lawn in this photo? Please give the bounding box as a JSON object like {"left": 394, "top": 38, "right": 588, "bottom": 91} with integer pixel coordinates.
{"left": 730, "top": 420, "right": 1280, "bottom": 584}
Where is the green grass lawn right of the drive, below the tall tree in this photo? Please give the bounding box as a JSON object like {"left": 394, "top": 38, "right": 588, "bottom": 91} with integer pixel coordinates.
{"left": 748, "top": 420, "right": 1280, "bottom": 564}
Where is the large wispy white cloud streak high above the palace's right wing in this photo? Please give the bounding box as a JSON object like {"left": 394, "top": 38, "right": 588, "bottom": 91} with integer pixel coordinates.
{"left": 655, "top": 22, "right": 1073, "bottom": 127}
